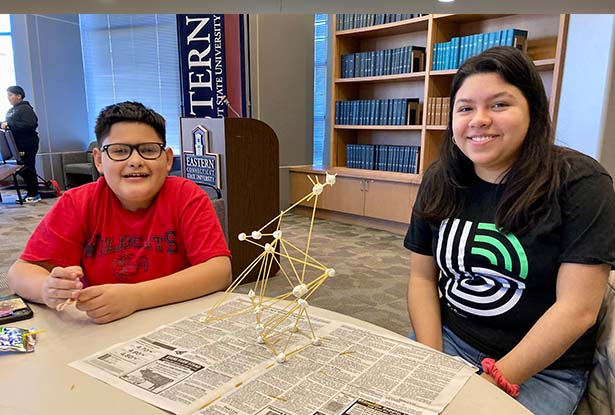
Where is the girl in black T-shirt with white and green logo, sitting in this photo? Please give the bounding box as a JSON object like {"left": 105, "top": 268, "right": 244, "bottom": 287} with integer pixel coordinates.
{"left": 404, "top": 47, "right": 615, "bottom": 415}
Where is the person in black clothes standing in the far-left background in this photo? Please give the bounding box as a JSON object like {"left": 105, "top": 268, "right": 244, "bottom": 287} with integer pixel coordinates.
{"left": 0, "top": 85, "right": 41, "bottom": 203}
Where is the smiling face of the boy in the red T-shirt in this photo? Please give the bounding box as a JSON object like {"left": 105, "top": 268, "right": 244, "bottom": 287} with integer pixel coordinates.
{"left": 93, "top": 122, "right": 173, "bottom": 211}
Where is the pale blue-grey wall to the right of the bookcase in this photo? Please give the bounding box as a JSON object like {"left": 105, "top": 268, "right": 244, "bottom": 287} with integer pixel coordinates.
{"left": 555, "top": 14, "right": 615, "bottom": 174}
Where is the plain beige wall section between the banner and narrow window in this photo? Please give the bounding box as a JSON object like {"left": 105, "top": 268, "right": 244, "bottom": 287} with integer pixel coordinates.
{"left": 249, "top": 14, "right": 314, "bottom": 208}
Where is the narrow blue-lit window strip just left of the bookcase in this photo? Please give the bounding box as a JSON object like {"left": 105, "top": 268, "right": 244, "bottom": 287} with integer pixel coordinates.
{"left": 312, "top": 14, "right": 329, "bottom": 166}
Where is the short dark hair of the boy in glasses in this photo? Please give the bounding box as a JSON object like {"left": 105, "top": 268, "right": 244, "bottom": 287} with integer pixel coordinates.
{"left": 94, "top": 101, "right": 167, "bottom": 147}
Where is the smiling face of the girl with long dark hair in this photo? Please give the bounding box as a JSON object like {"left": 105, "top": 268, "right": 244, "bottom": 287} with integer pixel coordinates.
{"left": 453, "top": 73, "right": 530, "bottom": 183}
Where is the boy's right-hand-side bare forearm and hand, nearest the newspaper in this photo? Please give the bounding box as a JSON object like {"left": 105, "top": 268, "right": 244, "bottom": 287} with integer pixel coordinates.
{"left": 77, "top": 256, "right": 231, "bottom": 324}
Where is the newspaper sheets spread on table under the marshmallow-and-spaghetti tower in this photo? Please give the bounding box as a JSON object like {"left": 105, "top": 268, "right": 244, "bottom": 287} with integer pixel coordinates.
{"left": 70, "top": 298, "right": 475, "bottom": 415}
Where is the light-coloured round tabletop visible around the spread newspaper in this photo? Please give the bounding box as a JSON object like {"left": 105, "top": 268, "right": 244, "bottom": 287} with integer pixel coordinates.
{"left": 0, "top": 293, "right": 530, "bottom": 415}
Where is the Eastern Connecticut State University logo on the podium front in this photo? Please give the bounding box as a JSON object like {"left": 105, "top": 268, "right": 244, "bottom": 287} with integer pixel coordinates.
{"left": 184, "top": 125, "right": 220, "bottom": 188}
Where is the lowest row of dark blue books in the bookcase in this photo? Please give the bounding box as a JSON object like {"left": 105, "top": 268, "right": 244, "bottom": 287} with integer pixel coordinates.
{"left": 346, "top": 144, "right": 421, "bottom": 174}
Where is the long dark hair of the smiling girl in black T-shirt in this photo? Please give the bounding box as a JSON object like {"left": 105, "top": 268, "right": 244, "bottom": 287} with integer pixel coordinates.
{"left": 416, "top": 47, "right": 563, "bottom": 234}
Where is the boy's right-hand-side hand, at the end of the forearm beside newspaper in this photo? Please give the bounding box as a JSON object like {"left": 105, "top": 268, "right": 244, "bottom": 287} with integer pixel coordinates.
{"left": 77, "top": 284, "right": 137, "bottom": 324}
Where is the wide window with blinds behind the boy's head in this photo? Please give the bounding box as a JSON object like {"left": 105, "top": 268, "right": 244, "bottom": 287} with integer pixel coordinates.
{"left": 79, "top": 14, "right": 181, "bottom": 154}
